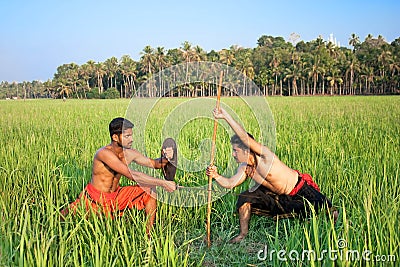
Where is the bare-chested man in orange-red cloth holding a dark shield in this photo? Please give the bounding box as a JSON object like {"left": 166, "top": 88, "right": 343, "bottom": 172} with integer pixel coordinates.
{"left": 61, "top": 118, "right": 177, "bottom": 234}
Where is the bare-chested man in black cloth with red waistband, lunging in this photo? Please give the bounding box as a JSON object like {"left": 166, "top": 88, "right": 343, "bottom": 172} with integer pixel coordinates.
{"left": 206, "top": 108, "right": 338, "bottom": 243}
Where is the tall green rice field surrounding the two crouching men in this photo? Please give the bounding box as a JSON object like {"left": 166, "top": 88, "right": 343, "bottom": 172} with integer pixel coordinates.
{"left": 0, "top": 96, "right": 400, "bottom": 267}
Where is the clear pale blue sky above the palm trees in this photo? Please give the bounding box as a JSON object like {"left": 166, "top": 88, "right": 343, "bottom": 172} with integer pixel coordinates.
{"left": 0, "top": 0, "right": 400, "bottom": 82}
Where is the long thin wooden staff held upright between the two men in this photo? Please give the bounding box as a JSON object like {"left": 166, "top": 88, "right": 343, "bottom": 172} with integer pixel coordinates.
{"left": 207, "top": 71, "right": 223, "bottom": 247}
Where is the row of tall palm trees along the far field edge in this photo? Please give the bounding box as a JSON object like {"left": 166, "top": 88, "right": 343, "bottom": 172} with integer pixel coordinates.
{"left": 0, "top": 34, "right": 400, "bottom": 98}
